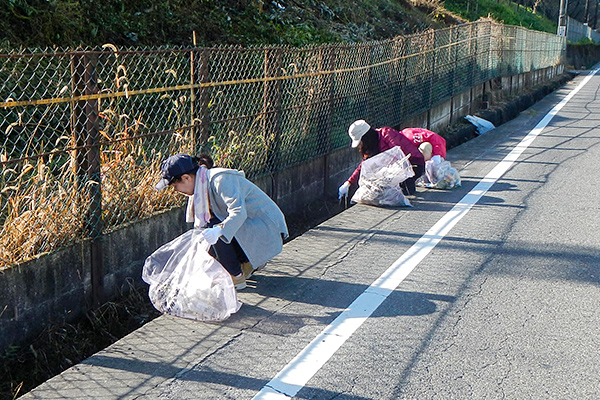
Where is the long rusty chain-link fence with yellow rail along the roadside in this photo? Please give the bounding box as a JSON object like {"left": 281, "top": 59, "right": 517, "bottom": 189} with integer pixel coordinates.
{"left": 0, "top": 21, "right": 564, "bottom": 269}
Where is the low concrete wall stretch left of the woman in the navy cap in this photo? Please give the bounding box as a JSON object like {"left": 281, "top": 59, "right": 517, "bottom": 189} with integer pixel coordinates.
{"left": 0, "top": 209, "right": 186, "bottom": 351}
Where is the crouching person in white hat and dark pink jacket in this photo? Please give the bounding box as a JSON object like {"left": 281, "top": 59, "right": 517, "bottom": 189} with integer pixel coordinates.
{"left": 338, "top": 119, "right": 425, "bottom": 198}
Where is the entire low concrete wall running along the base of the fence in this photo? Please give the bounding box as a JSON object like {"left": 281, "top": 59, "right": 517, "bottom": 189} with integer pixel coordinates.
{"left": 0, "top": 66, "right": 563, "bottom": 351}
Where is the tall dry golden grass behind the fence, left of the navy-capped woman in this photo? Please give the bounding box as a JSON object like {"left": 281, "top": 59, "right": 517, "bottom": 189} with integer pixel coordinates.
{"left": 0, "top": 54, "right": 193, "bottom": 270}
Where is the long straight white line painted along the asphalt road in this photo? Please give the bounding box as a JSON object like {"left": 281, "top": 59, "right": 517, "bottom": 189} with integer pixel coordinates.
{"left": 254, "top": 68, "right": 600, "bottom": 400}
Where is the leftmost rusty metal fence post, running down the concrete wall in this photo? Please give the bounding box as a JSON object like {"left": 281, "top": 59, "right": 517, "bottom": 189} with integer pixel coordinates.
{"left": 71, "top": 52, "right": 104, "bottom": 307}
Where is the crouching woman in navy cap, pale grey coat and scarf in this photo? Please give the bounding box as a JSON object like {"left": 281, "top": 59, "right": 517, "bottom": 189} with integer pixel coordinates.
{"left": 156, "top": 154, "right": 288, "bottom": 290}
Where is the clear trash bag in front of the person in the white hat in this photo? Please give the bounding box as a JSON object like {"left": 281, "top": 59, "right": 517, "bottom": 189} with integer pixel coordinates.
{"left": 351, "top": 146, "right": 415, "bottom": 207}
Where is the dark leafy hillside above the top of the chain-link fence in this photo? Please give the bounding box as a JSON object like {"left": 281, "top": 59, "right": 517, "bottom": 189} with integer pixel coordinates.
{"left": 0, "top": 0, "right": 578, "bottom": 48}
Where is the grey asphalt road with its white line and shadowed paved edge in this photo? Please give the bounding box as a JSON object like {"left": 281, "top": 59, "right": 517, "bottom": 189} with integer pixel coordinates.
{"left": 23, "top": 67, "right": 600, "bottom": 400}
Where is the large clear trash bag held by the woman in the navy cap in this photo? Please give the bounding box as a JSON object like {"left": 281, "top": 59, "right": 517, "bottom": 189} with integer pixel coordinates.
{"left": 142, "top": 229, "right": 242, "bottom": 321}
